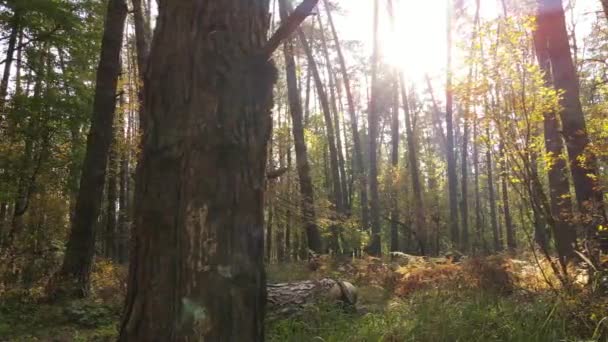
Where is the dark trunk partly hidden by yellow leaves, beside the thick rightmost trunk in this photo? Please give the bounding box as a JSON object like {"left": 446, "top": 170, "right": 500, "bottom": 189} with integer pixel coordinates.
{"left": 533, "top": 25, "right": 576, "bottom": 265}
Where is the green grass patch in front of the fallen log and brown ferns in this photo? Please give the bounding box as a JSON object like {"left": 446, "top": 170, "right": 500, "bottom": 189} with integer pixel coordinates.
{"left": 267, "top": 291, "right": 593, "bottom": 342}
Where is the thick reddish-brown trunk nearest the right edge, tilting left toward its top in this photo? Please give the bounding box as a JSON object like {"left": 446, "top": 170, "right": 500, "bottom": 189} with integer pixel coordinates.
{"left": 536, "top": 0, "right": 608, "bottom": 251}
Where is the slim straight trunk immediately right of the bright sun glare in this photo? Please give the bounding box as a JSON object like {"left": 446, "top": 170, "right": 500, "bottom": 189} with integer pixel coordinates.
{"left": 445, "top": 0, "right": 460, "bottom": 247}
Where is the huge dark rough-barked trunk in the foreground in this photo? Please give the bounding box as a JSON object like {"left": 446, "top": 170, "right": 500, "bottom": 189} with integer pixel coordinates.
{"left": 119, "top": 0, "right": 276, "bottom": 341}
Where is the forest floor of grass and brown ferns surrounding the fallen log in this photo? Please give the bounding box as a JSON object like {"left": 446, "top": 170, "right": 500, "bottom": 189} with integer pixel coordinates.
{"left": 0, "top": 256, "right": 608, "bottom": 342}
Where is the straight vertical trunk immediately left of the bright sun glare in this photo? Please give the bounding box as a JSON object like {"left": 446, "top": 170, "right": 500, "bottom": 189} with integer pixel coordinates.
{"left": 367, "top": 0, "right": 382, "bottom": 256}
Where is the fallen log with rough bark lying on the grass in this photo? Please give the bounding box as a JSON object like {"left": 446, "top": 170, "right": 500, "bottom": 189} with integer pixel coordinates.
{"left": 267, "top": 278, "right": 357, "bottom": 317}
